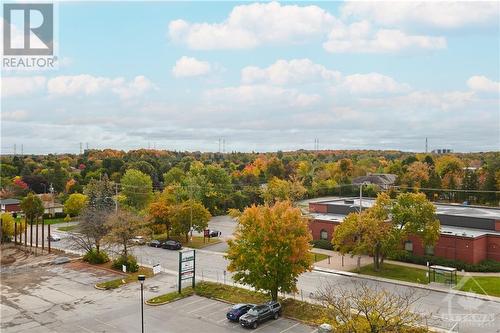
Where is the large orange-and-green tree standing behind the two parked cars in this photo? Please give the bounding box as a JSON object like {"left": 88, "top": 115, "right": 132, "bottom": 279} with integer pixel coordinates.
{"left": 226, "top": 201, "right": 312, "bottom": 300}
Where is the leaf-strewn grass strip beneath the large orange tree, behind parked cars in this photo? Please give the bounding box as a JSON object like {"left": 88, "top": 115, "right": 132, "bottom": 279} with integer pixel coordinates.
{"left": 195, "top": 282, "right": 326, "bottom": 325}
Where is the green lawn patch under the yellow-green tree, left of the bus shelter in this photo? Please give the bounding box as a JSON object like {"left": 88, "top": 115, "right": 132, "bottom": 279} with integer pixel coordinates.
{"left": 352, "top": 263, "right": 429, "bottom": 284}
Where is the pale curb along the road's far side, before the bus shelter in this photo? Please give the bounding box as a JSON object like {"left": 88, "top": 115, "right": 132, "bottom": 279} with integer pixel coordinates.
{"left": 313, "top": 266, "right": 500, "bottom": 302}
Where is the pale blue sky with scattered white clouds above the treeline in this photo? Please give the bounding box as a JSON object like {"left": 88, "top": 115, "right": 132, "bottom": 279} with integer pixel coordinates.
{"left": 1, "top": 1, "right": 500, "bottom": 154}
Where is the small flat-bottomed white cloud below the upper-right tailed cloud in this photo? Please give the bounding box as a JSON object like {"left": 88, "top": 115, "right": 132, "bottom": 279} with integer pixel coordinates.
{"left": 334, "top": 73, "right": 410, "bottom": 94}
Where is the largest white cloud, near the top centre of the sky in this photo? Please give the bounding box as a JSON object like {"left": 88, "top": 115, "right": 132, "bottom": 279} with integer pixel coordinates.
{"left": 168, "top": 2, "right": 335, "bottom": 50}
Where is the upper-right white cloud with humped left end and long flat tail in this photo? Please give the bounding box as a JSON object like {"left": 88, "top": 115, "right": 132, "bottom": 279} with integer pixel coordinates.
{"left": 323, "top": 21, "right": 446, "bottom": 53}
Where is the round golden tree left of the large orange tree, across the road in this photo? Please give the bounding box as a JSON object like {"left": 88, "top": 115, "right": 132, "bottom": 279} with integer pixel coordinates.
{"left": 170, "top": 200, "right": 212, "bottom": 242}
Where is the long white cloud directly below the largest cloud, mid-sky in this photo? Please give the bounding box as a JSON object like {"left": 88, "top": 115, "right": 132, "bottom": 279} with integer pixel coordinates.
{"left": 241, "top": 59, "right": 340, "bottom": 85}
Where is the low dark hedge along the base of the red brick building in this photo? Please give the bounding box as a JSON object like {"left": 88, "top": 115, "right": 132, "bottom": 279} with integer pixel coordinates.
{"left": 389, "top": 252, "right": 500, "bottom": 272}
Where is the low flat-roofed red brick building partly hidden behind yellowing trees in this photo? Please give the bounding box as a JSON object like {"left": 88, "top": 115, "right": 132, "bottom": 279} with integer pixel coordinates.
{"left": 309, "top": 198, "right": 500, "bottom": 264}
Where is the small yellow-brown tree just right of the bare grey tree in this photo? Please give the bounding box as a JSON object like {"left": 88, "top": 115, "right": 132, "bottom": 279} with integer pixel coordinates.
{"left": 104, "top": 210, "right": 148, "bottom": 257}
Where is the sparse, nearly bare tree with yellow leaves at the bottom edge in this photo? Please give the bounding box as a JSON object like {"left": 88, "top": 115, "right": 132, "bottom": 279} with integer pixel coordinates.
{"left": 315, "top": 282, "right": 429, "bottom": 333}
